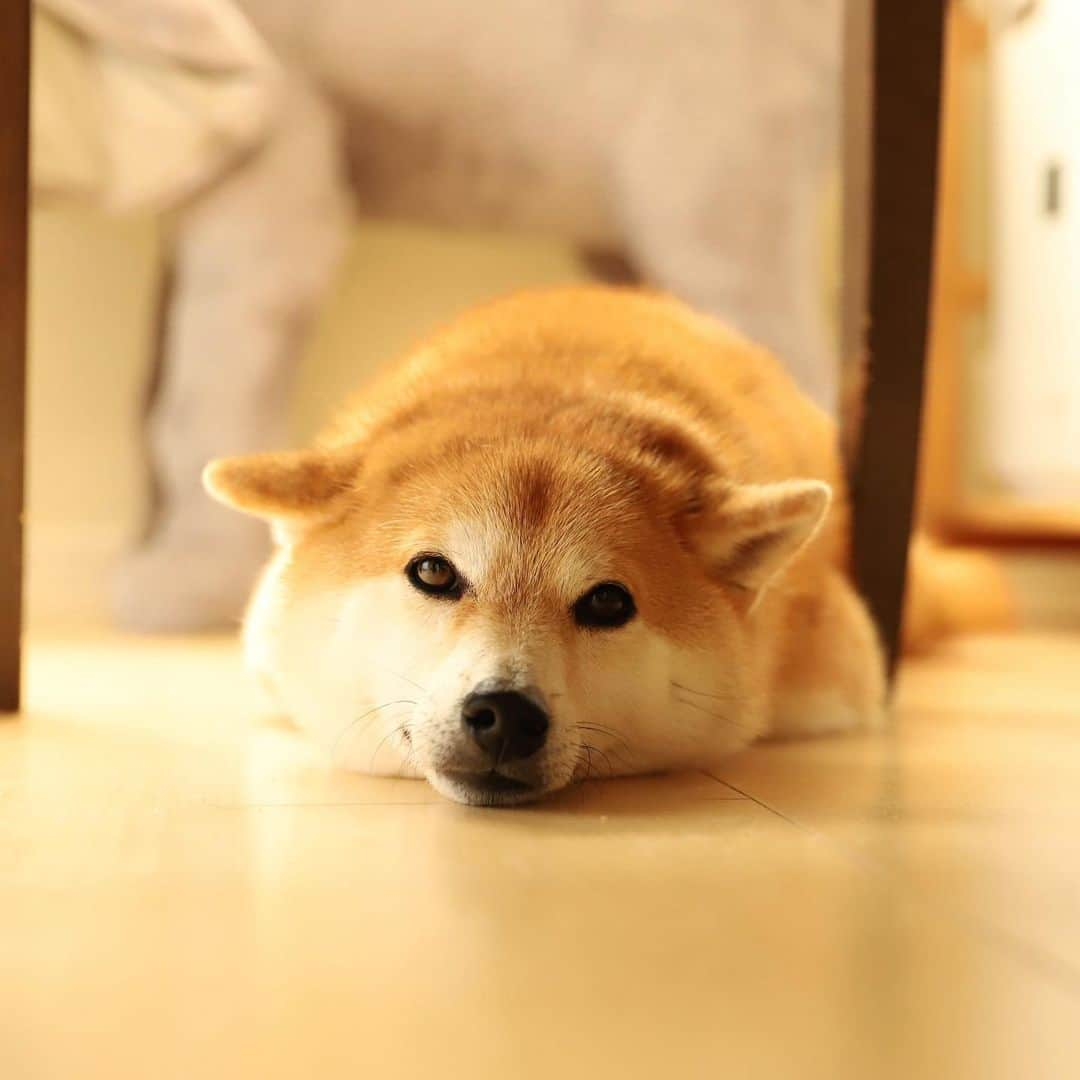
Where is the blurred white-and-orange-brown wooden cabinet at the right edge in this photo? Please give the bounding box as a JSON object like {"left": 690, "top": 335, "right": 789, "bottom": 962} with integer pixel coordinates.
{"left": 919, "top": 0, "right": 1080, "bottom": 540}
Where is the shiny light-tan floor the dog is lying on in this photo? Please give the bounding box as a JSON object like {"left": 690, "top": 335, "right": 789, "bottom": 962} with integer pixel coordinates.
{"left": 0, "top": 636, "right": 1080, "bottom": 1080}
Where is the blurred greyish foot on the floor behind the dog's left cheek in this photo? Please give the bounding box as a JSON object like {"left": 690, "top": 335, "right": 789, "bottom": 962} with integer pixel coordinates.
{"left": 110, "top": 520, "right": 269, "bottom": 634}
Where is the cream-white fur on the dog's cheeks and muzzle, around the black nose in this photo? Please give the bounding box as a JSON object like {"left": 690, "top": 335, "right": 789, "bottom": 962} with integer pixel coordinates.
{"left": 246, "top": 537, "right": 764, "bottom": 801}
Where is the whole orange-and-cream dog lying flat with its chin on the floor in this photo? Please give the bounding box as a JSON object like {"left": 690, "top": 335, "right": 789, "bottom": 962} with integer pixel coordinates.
{"left": 205, "top": 287, "right": 883, "bottom": 805}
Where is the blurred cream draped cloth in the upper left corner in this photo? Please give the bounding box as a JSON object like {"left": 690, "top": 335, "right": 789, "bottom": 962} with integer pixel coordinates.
{"left": 31, "top": 0, "right": 279, "bottom": 212}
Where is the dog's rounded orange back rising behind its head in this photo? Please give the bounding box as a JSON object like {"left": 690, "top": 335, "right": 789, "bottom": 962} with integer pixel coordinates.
{"left": 322, "top": 286, "right": 843, "bottom": 495}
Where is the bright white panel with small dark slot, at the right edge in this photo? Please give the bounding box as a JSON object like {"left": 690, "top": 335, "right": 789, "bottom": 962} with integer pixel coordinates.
{"left": 983, "top": 0, "right": 1080, "bottom": 499}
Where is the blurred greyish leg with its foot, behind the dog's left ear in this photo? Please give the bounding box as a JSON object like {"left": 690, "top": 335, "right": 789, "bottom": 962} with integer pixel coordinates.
{"left": 113, "top": 79, "right": 350, "bottom": 631}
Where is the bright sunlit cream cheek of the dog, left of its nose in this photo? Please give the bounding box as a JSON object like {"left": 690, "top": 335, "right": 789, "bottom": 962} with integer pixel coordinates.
{"left": 245, "top": 551, "right": 557, "bottom": 779}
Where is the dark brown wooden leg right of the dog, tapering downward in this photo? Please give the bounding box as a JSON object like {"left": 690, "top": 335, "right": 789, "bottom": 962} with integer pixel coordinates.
{"left": 845, "top": 0, "right": 945, "bottom": 671}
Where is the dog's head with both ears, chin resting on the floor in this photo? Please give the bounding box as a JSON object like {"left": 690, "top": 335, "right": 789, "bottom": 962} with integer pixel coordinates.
{"left": 208, "top": 436, "right": 827, "bottom": 805}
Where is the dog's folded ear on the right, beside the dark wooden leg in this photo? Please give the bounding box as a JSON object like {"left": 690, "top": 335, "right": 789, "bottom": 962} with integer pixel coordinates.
{"left": 696, "top": 480, "right": 833, "bottom": 592}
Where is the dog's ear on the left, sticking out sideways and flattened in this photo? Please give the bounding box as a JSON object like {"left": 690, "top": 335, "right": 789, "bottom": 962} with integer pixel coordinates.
{"left": 203, "top": 450, "right": 360, "bottom": 521}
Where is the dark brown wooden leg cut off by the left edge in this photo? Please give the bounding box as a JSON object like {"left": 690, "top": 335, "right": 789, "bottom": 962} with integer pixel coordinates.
{"left": 0, "top": 0, "right": 30, "bottom": 712}
